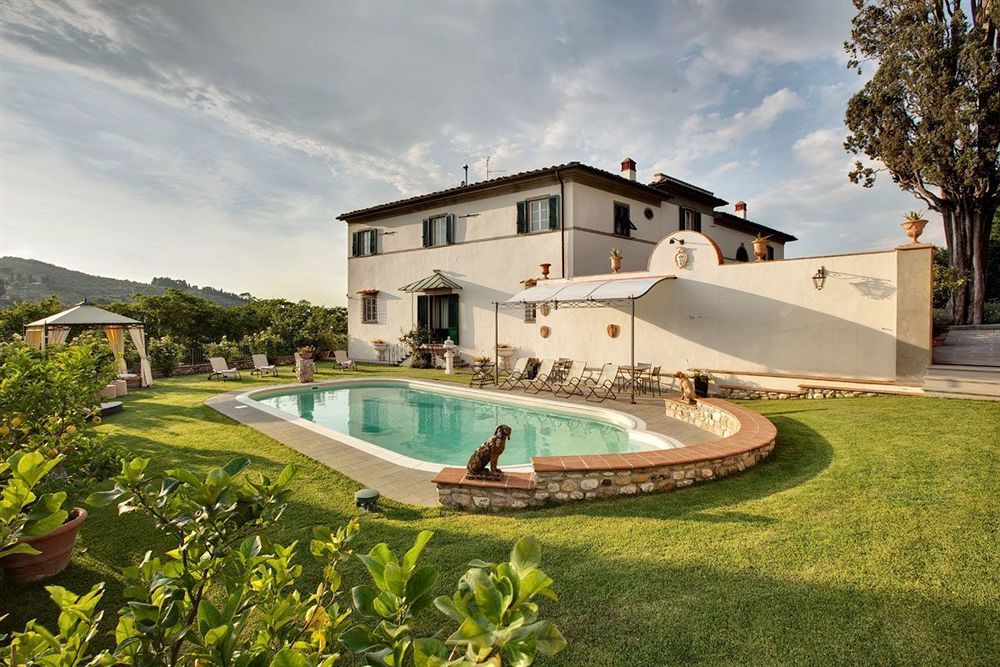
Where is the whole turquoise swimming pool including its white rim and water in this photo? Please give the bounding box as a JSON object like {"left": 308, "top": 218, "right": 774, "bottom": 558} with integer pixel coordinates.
{"left": 240, "top": 380, "right": 678, "bottom": 470}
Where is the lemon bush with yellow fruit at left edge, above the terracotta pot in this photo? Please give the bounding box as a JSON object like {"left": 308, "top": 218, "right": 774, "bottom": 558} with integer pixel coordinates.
{"left": 0, "top": 343, "right": 119, "bottom": 494}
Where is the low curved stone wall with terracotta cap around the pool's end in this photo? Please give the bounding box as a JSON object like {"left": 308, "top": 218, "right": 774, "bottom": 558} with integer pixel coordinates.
{"left": 433, "top": 398, "right": 777, "bottom": 512}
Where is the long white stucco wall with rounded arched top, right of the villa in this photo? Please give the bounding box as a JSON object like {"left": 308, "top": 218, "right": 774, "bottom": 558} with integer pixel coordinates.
{"left": 500, "top": 232, "right": 930, "bottom": 381}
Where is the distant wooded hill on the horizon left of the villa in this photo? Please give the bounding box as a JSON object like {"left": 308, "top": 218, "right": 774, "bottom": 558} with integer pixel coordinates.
{"left": 0, "top": 257, "right": 246, "bottom": 309}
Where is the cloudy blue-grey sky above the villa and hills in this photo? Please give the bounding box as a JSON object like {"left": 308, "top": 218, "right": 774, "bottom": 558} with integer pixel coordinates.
{"left": 0, "top": 0, "right": 942, "bottom": 306}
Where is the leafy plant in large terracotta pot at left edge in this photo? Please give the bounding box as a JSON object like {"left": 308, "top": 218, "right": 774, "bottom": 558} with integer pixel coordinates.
{"left": 0, "top": 451, "right": 87, "bottom": 584}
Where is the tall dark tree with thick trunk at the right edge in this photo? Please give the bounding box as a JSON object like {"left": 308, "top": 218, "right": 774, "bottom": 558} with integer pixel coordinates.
{"left": 844, "top": 0, "right": 1000, "bottom": 324}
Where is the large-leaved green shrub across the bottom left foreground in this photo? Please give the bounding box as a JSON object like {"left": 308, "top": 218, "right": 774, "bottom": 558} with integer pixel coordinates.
{"left": 0, "top": 459, "right": 566, "bottom": 667}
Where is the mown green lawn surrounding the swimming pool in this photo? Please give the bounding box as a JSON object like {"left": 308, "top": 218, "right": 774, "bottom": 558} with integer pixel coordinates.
{"left": 0, "top": 364, "right": 1000, "bottom": 666}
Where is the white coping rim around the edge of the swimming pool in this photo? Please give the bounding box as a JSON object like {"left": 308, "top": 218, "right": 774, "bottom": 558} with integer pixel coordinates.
{"left": 234, "top": 377, "right": 687, "bottom": 474}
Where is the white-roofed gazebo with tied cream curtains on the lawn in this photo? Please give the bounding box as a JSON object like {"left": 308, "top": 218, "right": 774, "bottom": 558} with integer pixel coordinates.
{"left": 24, "top": 299, "right": 153, "bottom": 387}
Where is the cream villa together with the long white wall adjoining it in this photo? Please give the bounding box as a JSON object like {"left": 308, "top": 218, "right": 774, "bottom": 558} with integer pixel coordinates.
{"left": 339, "top": 159, "right": 932, "bottom": 398}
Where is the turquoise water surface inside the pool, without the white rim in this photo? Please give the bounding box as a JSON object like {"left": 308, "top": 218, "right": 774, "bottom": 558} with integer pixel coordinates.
{"left": 255, "top": 383, "right": 638, "bottom": 468}
